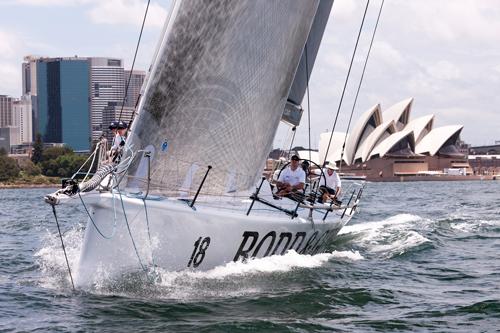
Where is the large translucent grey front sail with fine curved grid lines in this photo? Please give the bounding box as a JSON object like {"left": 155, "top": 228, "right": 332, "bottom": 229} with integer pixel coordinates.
{"left": 122, "top": 0, "right": 319, "bottom": 193}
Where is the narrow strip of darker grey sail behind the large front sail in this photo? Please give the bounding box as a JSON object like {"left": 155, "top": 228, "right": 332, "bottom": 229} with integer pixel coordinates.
{"left": 282, "top": 0, "right": 333, "bottom": 125}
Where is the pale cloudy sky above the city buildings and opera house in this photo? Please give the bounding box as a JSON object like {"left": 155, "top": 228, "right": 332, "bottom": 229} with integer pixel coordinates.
{"left": 0, "top": 0, "right": 500, "bottom": 148}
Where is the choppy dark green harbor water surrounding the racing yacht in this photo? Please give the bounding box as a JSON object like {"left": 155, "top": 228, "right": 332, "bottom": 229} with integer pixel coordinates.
{"left": 0, "top": 181, "right": 500, "bottom": 332}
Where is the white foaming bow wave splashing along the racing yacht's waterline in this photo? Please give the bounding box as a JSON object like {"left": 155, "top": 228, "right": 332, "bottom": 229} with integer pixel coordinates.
{"left": 35, "top": 228, "right": 364, "bottom": 300}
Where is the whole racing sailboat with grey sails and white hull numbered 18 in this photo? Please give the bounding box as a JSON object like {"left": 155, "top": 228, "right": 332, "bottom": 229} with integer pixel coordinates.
{"left": 46, "top": 0, "right": 362, "bottom": 287}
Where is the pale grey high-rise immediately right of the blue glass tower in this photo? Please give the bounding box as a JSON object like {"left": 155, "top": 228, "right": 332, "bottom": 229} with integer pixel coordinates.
{"left": 89, "top": 58, "right": 125, "bottom": 141}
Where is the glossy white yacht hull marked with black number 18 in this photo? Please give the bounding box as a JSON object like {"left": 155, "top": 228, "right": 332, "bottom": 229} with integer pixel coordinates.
{"left": 75, "top": 192, "right": 353, "bottom": 287}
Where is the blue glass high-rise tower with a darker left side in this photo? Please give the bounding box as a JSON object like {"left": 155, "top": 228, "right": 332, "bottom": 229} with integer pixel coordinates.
{"left": 33, "top": 57, "right": 91, "bottom": 151}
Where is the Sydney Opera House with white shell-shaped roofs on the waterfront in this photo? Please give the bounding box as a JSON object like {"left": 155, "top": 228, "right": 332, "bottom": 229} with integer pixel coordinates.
{"left": 318, "top": 98, "right": 471, "bottom": 181}
